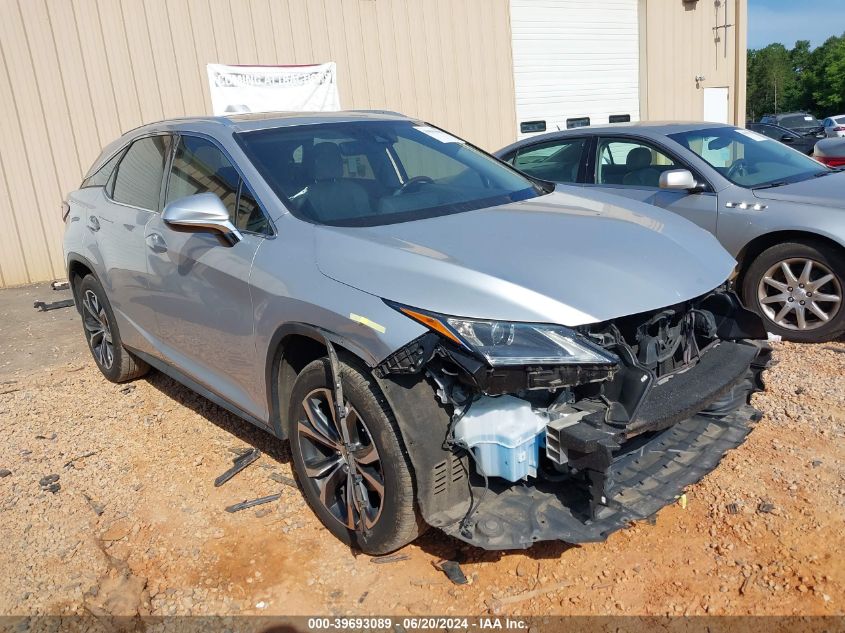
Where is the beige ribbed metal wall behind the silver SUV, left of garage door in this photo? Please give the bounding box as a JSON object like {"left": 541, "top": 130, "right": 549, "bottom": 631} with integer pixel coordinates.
{"left": 0, "top": 0, "right": 516, "bottom": 287}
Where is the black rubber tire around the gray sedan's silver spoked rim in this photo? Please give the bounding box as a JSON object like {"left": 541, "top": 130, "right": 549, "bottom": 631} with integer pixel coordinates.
{"left": 742, "top": 242, "right": 845, "bottom": 343}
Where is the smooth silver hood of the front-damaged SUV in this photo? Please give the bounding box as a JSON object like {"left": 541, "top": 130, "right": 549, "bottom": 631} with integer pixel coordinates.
{"left": 316, "top": 188, "right": 735, "bottom": 326}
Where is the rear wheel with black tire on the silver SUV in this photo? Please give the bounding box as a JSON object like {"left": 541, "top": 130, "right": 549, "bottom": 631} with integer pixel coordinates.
{"left": 76, "top": 275, "right": 150, "bottom": 382}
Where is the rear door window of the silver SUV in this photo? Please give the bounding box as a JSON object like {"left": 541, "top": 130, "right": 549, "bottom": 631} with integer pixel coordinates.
{"left": 111, "top": 136, "right": 170, "bottom": 211}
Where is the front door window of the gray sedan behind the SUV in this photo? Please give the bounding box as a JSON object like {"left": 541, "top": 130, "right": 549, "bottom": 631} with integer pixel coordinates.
{"left": 596, "top": 139, "right": 678, "bottom": 187}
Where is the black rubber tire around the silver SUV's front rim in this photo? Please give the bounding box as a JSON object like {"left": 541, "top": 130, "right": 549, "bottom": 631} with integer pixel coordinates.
{"left": 287, "top": 358, "right": 423, "bottom": 555}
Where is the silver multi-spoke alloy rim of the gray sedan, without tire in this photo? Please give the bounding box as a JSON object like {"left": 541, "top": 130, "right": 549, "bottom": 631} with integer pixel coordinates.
{"left": 757, "top": 257, "right": 842, "bottom": 330}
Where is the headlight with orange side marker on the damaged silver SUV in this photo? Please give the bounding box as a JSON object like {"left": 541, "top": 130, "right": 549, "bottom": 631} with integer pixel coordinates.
{"left": 388, "top": 304, "right": 618, "bottom": 367}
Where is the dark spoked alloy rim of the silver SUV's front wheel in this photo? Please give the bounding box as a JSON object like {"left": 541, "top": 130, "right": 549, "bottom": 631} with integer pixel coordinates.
{"left": 297, "top": 388, "right": 384, "bottom": 530}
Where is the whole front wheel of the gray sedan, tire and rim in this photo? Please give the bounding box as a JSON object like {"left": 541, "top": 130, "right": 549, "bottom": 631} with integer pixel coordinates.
{"left": 743, "top": 243, "right": 845, "bottom": 342}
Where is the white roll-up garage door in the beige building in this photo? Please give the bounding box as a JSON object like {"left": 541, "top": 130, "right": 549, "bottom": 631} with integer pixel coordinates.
{"left": 510, "top": 0, "right": 640, "bottom": 138}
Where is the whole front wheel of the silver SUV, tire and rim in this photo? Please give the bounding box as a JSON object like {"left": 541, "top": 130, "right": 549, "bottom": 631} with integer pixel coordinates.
{"left": 287, "top": 358, "right": 421, "bottom": 555}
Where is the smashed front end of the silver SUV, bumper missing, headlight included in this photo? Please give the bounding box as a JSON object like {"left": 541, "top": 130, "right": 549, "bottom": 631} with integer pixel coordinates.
{"left": 374, "top": 289, "right": 771, "bottom": 549}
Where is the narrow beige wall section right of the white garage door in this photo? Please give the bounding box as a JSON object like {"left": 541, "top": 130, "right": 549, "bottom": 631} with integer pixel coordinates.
{"left": 640, "top": 0, "right": 748, "bottom": 126}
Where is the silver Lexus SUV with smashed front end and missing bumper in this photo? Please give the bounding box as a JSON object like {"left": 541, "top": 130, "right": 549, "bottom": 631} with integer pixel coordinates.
{"left": 64, "top": 112, "right": 768, "bottom": 553}
